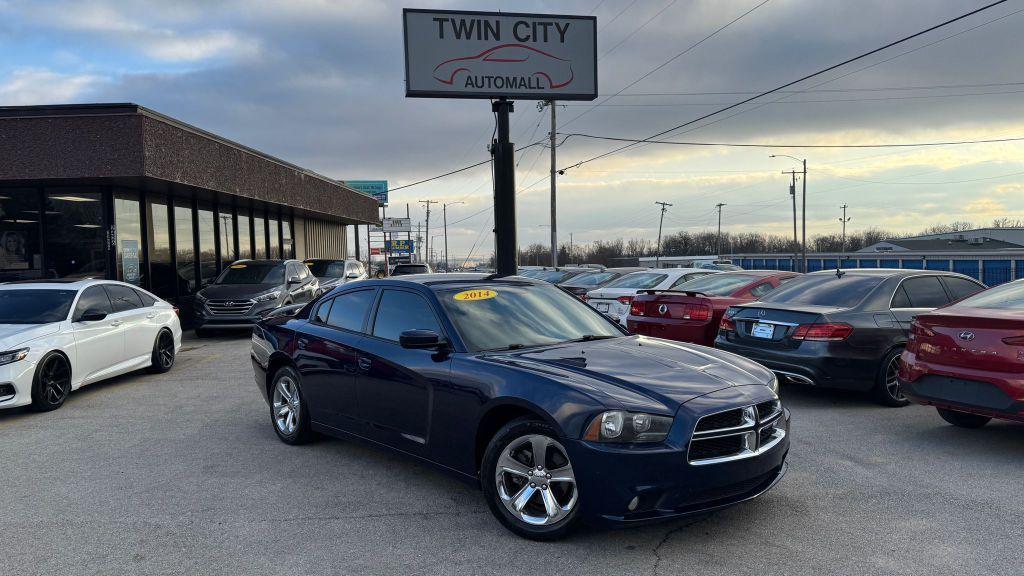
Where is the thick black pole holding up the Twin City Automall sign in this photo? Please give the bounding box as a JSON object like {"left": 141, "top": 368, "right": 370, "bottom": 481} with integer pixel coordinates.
{"left": 490, "top": 98, "right": 517, "bottom": 276}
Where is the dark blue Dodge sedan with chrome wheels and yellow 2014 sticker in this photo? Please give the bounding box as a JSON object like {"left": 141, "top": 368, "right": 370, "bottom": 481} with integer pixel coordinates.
{"left": 252, "top": 274, "right": 790, "bottom": 540}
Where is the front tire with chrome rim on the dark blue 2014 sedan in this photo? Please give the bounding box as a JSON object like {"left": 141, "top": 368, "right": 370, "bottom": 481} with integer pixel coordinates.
{"left": 480, "top": 418, "right": 580, "bottom": 540}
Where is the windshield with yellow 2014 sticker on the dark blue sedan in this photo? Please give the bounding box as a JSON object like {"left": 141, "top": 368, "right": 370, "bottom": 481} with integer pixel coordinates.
{"left": 437, "top": 283, "right": 623, "bottom": 352}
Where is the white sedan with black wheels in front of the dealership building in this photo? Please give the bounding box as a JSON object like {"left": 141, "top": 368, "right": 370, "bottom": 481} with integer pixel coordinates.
{"left": 0, "top": 280, "right": 181, "bottom": 412}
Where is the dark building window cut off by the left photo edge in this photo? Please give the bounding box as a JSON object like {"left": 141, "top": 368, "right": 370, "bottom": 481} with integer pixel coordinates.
{"left": 0, "top": 189, "right": 43, "bottom": 281}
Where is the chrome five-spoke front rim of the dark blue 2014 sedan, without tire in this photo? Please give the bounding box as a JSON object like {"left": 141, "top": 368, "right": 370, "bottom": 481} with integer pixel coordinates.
{"left": 495, "top": 435, "right": 579, "bottom": 526}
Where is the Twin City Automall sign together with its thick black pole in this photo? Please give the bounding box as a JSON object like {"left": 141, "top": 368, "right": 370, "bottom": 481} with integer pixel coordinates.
{"left": 402, "top": 8, "right": 597, "bottom": 276}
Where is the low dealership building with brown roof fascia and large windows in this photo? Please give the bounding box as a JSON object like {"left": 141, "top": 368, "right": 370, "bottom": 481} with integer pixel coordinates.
{"left": 0, "top": 104, "right": 379, "bottom": 305}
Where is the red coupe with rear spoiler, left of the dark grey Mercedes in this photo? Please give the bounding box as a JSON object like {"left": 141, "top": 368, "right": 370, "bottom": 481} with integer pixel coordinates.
{"left": 626, "top": 270, "right": 800, "bottom": 346}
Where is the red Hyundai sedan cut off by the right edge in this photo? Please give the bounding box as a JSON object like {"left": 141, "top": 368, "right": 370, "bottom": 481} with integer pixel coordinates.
{"left": 899, "top": 280, "right": 1024, "bottom": 428}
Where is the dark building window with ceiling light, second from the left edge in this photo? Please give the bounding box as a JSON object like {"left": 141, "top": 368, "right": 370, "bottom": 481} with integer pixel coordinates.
{"left": 43, "top": 188, "right": 106, "bottom": 278}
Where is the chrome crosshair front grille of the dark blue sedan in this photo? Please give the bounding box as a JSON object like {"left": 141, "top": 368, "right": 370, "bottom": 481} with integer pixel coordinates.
{"left": 686, "top": 400, "right": 786, "bottom": 465}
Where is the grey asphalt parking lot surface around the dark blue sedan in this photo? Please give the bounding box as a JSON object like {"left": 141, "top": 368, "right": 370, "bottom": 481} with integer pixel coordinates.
{"left": 0, "top": 336, "right": 1024, "bottom": 576}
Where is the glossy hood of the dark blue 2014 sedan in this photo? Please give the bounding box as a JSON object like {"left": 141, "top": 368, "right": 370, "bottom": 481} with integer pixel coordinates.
{"left": 487, "top": 336, "right": 773, "bottom": 414}
